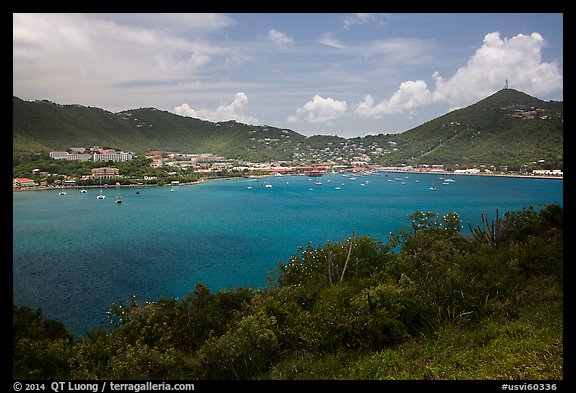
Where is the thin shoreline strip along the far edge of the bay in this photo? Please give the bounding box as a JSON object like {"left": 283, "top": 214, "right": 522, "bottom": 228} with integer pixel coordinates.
{"left": 12, "top": 170, "right": 564, "bottom": 192}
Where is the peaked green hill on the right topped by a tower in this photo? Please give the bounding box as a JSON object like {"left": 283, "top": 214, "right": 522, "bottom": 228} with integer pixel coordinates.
{"left": 364, "top": 89, "right": 563, "bottom": 167}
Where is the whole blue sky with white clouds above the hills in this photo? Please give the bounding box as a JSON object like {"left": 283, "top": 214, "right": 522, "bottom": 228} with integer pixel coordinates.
{"left": 13, "top": 13, "right": 564, "bottom": 138}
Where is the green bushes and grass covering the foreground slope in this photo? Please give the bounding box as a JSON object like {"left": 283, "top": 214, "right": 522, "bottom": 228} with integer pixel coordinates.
{"left": 13, "top": 205, "right": 563, "bottom": 380}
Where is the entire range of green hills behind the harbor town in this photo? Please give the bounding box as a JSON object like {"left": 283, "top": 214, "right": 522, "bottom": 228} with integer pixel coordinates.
{"left": 12, "top": 89, "right": 564, "bottom": 169}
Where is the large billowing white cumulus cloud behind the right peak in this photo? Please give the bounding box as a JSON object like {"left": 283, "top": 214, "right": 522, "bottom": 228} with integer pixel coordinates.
{"left": 355, "top": 32, "right": 563, "bottom": 118}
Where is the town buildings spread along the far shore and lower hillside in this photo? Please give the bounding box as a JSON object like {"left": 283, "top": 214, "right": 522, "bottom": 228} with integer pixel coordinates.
{"left": 13, "top": 145, "right": 563, "bottom": 190}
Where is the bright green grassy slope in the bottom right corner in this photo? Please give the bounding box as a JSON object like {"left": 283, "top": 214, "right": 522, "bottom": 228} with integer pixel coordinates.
{"left": 266, "top": 274, "right": 564, "bottom": 380}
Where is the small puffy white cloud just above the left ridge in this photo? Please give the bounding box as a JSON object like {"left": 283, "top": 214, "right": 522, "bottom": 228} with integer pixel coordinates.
{"left": 174, "top": 93, "right": 258, "bottom": 124}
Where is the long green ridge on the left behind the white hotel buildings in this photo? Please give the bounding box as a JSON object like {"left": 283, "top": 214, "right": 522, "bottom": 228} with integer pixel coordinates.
{"left": 12, "top": 97, "right": 305, "bottom": 161}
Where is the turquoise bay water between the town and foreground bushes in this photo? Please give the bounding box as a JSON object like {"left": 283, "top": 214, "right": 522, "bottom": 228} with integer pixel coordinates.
{"left": 12, "top": 173, "right": 563, "bottom": 335}
